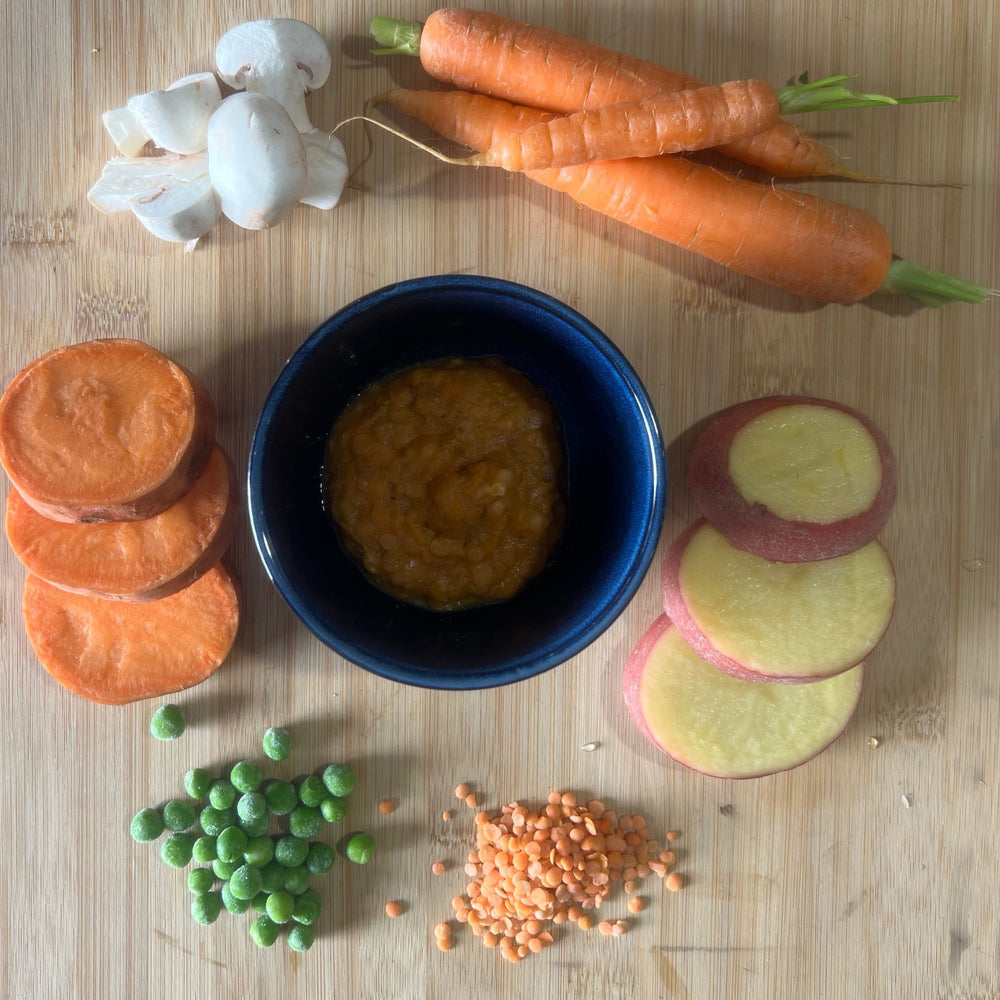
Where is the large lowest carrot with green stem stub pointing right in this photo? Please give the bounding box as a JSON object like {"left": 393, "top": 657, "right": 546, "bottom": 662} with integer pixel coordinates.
{"left": 378, "top": 89, "right": 989, "bottom": 306}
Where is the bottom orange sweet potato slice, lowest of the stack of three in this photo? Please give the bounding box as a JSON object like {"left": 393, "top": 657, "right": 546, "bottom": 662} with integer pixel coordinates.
{"left": 23, "top": 562, "right": 240, "bottom": 705}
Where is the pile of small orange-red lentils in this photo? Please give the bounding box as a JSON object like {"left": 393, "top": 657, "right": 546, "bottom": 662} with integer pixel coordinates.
{"left": 450, "top": 786, "right": 683, "bottom": 962}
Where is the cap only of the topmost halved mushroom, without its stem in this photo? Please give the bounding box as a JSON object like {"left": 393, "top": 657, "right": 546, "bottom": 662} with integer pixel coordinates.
{"left": 215, "top": 17, "right": 330, "bottom": 93}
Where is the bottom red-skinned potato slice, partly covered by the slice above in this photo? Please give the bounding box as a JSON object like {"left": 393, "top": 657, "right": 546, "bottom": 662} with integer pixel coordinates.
{"left": 623, "top": 615, "right": 864, "bottom": 778}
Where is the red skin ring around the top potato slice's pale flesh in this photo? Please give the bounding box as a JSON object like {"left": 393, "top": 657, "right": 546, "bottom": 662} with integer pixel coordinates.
{"left": 688, "top": 396, "right": 898, "bottom": 562}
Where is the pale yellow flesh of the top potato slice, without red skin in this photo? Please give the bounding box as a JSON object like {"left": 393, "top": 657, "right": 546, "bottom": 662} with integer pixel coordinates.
{"left": 729, "top": 404, "right": 882, "bottom": 524}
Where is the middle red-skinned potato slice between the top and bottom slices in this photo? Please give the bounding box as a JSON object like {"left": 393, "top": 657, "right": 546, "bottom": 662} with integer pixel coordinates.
{"left": 663, "top": 519, "right": 896, "bottom": 682}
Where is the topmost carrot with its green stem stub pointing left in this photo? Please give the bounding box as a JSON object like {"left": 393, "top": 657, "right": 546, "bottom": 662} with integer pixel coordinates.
{"left": 372, "top": 8, "right": 867, "bottom": 179}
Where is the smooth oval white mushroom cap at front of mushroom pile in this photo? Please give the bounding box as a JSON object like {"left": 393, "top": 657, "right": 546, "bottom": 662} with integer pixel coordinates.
{"left": 208, "top": 93, "right": 306, "bottom": 229}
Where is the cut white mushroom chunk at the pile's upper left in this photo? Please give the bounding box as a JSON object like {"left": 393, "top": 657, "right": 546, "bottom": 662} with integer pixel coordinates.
{"left": 102, "top": 73, "right": 222, "bottom": 156}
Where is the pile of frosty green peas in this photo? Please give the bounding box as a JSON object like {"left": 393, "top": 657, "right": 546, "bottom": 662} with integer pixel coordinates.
{"left": 130, "top": 720, "right": 375, "bottom": 951}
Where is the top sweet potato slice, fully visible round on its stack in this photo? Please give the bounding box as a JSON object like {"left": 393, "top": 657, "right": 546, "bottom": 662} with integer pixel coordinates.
{"left": 0, "top": 338, "right": 215, "bottom": 521}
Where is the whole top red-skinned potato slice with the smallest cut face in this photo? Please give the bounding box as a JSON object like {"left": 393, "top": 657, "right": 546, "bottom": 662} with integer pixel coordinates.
{"left": 688, "top": 396, "right": 897, "bottom": 562}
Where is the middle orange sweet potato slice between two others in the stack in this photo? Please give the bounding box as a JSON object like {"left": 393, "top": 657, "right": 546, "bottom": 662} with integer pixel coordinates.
{"left": 6, "top": 445, "right": 238, "bottom": 601}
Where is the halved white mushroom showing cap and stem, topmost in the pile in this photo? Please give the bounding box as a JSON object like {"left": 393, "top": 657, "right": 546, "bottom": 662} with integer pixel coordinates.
{"left": 215, "top": 18, "right": 330, "bottom": 132}
